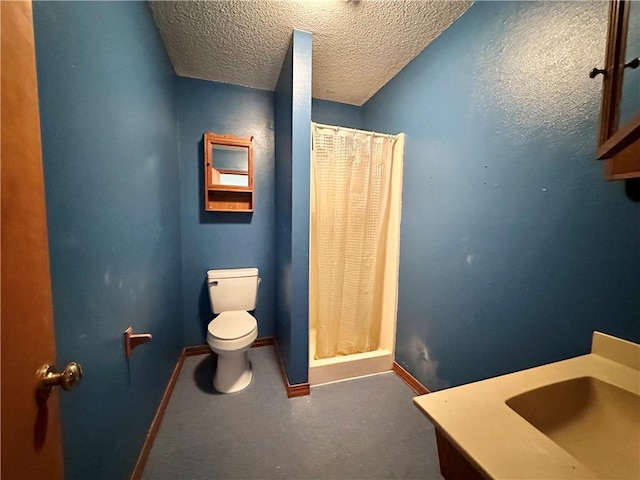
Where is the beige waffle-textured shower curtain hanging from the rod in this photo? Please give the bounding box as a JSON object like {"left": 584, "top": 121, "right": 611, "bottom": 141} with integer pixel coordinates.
{"left": 309, "top": 123, "right": 402, "bottom": 359}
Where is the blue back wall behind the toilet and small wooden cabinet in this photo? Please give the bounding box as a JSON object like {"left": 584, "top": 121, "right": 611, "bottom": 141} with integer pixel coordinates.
{"left": 177, "top": 78, "right": 276, "bottom": 345}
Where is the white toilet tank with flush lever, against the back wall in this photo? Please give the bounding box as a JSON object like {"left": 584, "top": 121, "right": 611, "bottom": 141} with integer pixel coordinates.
{"left": 207, "top": 268, "right": 260, "bottom": 313}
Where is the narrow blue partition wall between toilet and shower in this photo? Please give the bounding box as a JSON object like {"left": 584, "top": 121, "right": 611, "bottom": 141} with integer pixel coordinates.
{"left": 275, "top": 30, "right": 311, "bottom": 384}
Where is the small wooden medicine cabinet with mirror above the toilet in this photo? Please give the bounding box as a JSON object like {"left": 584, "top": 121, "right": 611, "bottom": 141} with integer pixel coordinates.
{"left": 204, "top": 132, "right": 253, "bottom": 212}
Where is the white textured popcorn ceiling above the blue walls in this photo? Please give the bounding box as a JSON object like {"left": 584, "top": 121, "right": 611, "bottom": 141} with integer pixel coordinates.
{"left": 149, "top": 0, "right": 472, "bottom": 105}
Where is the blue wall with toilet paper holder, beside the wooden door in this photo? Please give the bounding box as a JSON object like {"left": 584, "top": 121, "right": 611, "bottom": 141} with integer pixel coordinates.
{"left": 34, "top": 2, "right": 183, "bottom": 480}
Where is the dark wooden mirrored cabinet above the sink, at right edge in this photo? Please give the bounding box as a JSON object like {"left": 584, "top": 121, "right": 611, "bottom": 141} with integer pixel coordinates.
{"left": 589, "top": 0, "right": 640, "bottom": 180}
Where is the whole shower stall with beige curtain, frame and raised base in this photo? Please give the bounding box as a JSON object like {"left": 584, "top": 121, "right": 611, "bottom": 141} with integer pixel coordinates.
{"left": 309, "top": 123, "right": 404, "bottom": 385}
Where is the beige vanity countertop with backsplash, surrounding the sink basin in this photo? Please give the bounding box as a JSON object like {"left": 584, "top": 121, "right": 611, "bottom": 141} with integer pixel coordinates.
{"left": 414, "top": 332, "right": 640, "bottom": 479}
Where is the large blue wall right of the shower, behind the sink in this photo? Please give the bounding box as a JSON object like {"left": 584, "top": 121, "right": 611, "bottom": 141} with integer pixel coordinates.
{"left": 363, "top": 2, "right": 640, "bottom": 389}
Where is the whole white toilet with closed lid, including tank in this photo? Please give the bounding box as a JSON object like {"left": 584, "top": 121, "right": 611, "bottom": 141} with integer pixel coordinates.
{"left": 207, "top": 268, "right": 260, "bottom": 393}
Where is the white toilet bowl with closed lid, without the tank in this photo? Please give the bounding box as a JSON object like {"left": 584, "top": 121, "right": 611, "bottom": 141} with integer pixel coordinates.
{"left": 207, "top": 310, "right": 258, "bottom": 393}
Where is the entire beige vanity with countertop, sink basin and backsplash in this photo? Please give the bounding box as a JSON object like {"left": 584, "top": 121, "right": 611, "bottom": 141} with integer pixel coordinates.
{"left": 414, "top": 332, "right": 640, "bottom": 480}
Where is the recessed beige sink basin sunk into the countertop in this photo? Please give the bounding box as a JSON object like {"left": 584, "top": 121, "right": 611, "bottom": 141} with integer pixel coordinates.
{"left": 506, "top": 376, "right": 640, "bottom": 479}
